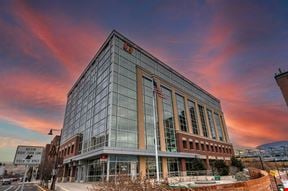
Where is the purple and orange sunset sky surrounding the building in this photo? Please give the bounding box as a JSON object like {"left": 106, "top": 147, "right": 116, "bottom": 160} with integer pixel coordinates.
{"left": 0, "top": 0, "right": 288, "bottom": 161}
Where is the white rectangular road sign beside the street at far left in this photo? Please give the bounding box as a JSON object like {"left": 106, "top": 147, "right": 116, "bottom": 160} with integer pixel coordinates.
{"left": 13, "top": 145, "right": 43, "bottom": 165}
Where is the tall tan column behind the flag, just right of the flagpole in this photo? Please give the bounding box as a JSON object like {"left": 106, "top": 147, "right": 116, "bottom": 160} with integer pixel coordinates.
{"left": 155, "top": 79, "right": 166, "bottom": 151}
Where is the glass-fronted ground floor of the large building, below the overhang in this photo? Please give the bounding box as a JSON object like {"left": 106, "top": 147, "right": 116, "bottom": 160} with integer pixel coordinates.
{"left": 62, "top": 155, "right": 227, "bottom": 182}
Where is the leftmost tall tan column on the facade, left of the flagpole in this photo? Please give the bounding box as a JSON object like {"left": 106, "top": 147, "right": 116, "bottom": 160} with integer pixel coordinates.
{"left": 136, "top": 67, "right": 145, "bottom": 149}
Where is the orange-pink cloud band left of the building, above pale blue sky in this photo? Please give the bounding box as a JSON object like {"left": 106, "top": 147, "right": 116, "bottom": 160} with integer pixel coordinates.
{"left": 0, "top": 73, "right": 68, "bottom": 132}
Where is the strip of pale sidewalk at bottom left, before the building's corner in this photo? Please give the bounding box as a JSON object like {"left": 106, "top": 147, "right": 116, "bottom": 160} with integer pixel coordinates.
{"left": 55, "top": 182, "right": 96, "bottom": 191}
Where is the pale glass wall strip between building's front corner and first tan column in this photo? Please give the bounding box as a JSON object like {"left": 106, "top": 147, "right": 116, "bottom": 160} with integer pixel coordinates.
{"left": 110, "top": 37, "right": 138, "bottom": 148}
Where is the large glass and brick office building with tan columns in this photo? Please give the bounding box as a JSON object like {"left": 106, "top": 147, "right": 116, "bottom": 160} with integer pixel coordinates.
{"left": 60, "top": 31, "right": 233, "bottom": 181}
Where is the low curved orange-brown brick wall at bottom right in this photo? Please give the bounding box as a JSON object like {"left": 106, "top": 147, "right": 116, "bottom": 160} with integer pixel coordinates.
{"left": 175, "top": 169, "right": 272, "bottom": 191}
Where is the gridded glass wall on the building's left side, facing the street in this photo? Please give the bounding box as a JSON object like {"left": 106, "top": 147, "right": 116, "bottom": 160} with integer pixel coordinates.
{"left": 61, "top": 42, "right": 112, "bottom": 153}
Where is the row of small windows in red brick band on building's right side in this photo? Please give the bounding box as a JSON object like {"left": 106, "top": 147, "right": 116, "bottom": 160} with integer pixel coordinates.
{"left": 182, "top": 140, "right": 232, "bottom": 154}
